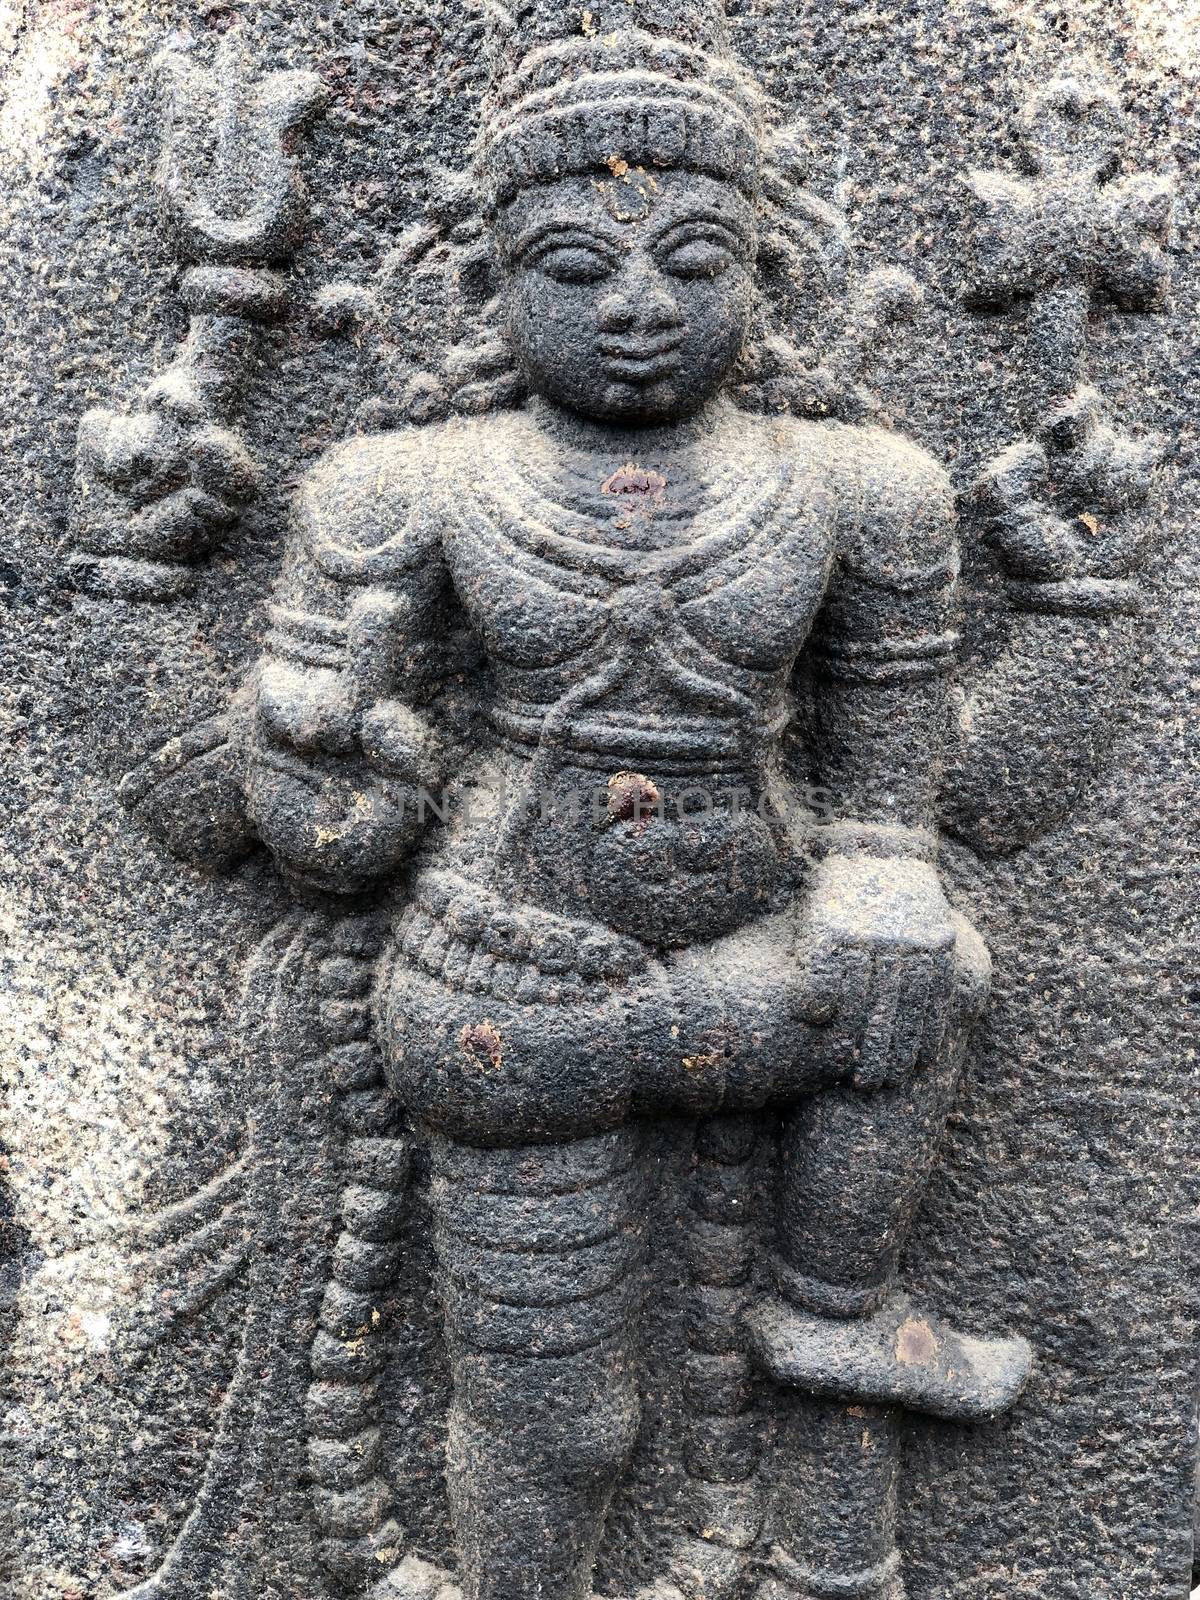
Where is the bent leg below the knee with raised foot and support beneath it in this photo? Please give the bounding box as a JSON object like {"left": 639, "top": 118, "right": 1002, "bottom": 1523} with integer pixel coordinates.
{"left": 750, "top": 934, "right": 1030, "bottom": 1600}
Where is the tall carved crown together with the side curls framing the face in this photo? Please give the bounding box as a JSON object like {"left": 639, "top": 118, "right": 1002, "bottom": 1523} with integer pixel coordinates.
{"left": 334, "top": 0, "right": 915, "bottom": 427}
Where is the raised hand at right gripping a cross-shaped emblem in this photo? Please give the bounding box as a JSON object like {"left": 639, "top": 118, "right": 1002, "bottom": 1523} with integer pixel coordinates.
{"left": 971, "top": 78, "right": 1174, "bottom": 611}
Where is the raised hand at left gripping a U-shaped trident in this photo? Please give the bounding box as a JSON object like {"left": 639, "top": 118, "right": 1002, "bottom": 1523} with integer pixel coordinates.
{"left": 70, "top": 30, "right": 323, "bottom": 600}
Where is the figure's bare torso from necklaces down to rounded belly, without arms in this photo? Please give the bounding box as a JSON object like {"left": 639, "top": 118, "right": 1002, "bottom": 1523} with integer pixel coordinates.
{"left": 445, "top": 411, "right": 837, "bottom": 944}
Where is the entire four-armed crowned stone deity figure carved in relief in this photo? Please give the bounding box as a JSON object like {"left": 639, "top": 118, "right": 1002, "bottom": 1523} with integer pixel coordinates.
{"left": 80, "top": 3, "right": 1170, "bottom": 1600}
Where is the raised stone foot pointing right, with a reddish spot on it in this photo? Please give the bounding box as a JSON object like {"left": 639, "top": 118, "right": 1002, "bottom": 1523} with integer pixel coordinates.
{"left": 747, "top": 1294, "right": 1034, "bottom": 1421}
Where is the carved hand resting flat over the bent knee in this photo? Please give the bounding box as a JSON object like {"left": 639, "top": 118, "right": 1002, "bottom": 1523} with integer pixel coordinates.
{"left": 803, "top": 854, "right": 957, "bottom": 1090}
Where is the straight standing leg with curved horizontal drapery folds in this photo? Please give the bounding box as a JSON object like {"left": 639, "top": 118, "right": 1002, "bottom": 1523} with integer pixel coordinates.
{"left": 434, "top": 1131, "right": 643, "bottom": 1600}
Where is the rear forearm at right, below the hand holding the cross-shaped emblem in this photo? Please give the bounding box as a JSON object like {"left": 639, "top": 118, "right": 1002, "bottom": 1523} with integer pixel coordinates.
{"left": 942, "top": 579, "right": 1139, "bottom": 854}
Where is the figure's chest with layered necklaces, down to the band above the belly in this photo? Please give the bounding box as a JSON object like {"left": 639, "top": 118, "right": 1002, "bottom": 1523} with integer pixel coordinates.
{"left": 446, "top": 400, "right": 837, "bottom": 755}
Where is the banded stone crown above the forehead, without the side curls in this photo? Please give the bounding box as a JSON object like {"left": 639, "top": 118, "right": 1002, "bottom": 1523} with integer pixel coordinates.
{"left": 478, "top": 0, "right": 763, "bottom": 205}
